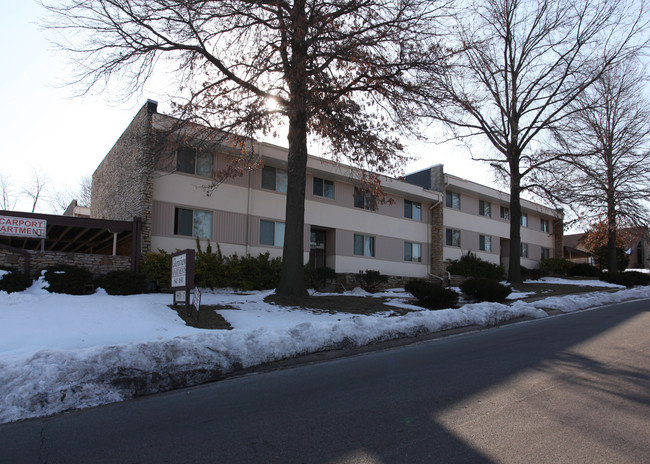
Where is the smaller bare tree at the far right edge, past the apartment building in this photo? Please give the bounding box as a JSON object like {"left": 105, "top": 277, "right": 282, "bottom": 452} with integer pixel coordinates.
{"left": 539, "top": 60, "right": 650, "bottom": 272}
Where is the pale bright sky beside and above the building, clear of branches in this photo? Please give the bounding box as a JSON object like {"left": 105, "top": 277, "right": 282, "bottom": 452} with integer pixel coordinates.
{"left": 0, "top": 0, "right": 494, "bottom": 213}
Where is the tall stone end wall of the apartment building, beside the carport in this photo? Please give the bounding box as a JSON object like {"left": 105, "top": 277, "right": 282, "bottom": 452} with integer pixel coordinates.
{"left": 90, "top": 102, "right": 157, "bottom": 254}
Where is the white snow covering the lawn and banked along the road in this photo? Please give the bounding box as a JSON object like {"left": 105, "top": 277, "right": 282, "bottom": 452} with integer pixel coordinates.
{"left": 0, "top": 274, "right": 650, "bottom": 423}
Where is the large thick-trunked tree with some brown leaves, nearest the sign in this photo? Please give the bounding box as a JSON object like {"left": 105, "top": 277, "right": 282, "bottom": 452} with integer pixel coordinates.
{"left": 47, "top": 0, "right": 446, "bottom": 295}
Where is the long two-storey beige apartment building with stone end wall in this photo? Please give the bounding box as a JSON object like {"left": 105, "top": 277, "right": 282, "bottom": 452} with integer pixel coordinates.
{"left": 91, "top": 101, "right": 562, "bottom": 277}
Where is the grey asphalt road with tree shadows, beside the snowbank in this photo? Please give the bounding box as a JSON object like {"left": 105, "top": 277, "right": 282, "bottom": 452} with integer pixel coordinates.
{"left": 0, "top": 300, "right": 650, "bottom": 464}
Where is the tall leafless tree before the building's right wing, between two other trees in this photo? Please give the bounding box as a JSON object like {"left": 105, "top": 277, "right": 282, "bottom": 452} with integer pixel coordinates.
{"left": 432, "top": 0, "right": 645, "bottom": 282}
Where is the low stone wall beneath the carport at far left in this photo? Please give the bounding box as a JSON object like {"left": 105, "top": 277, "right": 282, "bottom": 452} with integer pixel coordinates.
{"left": 0, "top": 249, "right": 131, "bottom": 277}
